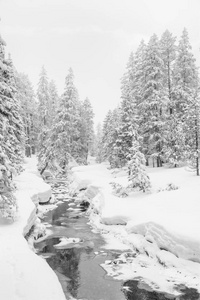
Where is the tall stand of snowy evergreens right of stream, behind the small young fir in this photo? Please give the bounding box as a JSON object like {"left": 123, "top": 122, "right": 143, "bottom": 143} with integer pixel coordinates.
{"left": 97, "top": 29, "right": 200, "bottom": 175}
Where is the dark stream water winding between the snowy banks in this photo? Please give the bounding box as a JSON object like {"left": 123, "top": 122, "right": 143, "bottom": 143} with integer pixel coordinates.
{"left": 35, "top": 185, "right": 200, "bottom": 300}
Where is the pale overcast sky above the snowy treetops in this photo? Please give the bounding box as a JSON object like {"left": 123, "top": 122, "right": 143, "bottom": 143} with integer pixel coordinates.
{"left": 0, "top": 0, "right": 200, "bottom": 123}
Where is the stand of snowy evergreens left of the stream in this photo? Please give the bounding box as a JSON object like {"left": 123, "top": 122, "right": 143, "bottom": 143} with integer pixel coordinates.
{"left": 0, "top": 32, "right": 94, "bottom": 218}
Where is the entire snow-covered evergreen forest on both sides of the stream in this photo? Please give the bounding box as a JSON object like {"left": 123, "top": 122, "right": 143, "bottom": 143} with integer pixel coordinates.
{"left": 0, "top": 29, "right": 200, "bottom": 218}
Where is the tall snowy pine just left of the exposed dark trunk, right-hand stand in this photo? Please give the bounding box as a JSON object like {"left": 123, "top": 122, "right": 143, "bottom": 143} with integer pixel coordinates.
{"left": 139, "top": 34, "right": 166, "bottom": 167}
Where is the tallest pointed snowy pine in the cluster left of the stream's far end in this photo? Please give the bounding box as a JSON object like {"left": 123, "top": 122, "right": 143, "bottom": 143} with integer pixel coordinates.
{"left": 46, "top": 68, "right": 80, "bottom": 172}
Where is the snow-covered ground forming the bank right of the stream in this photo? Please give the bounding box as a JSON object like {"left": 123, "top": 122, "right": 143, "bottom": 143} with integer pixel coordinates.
{"left": 71, "top": 164, "right": 200, "bottom": 294}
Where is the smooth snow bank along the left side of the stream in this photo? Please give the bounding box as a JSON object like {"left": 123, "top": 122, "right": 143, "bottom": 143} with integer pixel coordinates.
{"left": 0, "top": 157, "right": 65, "bottom": 300}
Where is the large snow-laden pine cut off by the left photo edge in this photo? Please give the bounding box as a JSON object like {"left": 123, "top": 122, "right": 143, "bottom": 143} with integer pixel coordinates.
{"left": 0, "top": 36, "right": 24, "bottom": 219}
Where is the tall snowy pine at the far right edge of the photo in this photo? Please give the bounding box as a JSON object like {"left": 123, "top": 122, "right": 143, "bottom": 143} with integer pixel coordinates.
{"left": 173, "top": 29, "right": 199, "bottom": 169}
